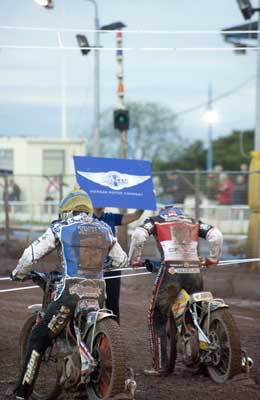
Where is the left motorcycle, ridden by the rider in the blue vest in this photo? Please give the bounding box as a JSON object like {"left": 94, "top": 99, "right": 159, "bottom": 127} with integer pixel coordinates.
{"left": 19, "top": 271, "right": 130, "bottom": 400}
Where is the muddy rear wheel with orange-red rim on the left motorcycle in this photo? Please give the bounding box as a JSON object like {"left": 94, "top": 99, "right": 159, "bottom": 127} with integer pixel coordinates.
{"left": 85, "top": 318, "right": 126, "bottom": 400}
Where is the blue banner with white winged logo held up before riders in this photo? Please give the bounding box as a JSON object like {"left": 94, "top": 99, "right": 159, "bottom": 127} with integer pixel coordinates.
{"left": 73, "top": 156, "right": 156, "bottom": 210}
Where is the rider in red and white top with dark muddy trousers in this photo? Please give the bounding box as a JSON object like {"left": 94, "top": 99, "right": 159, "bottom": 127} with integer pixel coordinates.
{"left": 129, "top": 206, "right": 223, "bottom": 376}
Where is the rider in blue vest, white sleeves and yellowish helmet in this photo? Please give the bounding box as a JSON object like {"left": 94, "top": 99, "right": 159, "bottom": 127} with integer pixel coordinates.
{"left": 11, "top": 190, "right": 127, "bottom": 399}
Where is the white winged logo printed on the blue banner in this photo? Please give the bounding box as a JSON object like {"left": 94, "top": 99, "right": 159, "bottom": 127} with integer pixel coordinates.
{"left": 77, "top": 171, "right": 151, "bottom": 190}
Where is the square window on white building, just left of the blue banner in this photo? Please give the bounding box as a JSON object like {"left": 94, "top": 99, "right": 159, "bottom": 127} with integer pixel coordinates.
{"left": 43, "top": 150, "right": 65, "bottom": 176}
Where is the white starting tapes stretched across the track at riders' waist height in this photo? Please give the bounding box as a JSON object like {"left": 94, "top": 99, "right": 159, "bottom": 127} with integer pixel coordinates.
{"left": 0, "top": 258, "right": 260, "bottom": 293}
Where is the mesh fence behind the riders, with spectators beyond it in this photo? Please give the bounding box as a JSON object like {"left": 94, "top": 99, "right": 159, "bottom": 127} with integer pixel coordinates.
{"left": 0, "top": 171, "right": 250, "bottom": 239}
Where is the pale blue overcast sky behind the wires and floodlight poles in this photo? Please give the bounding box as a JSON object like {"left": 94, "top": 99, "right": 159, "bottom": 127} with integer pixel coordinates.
{"left": 0, "top": 0, "right": 257, "bottom": 148}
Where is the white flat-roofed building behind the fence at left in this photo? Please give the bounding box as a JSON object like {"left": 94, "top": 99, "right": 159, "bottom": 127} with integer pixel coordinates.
{"left": 0, "top": 137, "right": 86, "bottom": 203}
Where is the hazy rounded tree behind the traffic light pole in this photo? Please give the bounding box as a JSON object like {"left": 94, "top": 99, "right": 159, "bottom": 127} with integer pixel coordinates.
{"left": 101, "top": 102, "right": 183, "bottom": 161}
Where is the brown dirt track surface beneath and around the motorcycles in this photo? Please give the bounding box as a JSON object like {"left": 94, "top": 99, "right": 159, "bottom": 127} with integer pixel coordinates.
{"left": 0, "top": 253, "right": 260, "bottom": 400}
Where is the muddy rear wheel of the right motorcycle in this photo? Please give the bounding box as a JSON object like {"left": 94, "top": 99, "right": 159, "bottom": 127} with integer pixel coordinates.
{"left": 203, "top": 308, "right": 241, "bottom": 383}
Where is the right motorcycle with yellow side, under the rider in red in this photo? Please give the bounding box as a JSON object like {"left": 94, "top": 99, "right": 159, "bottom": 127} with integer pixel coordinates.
{"left": 144, "top": 260, "right": 253, "bottom": 383}
